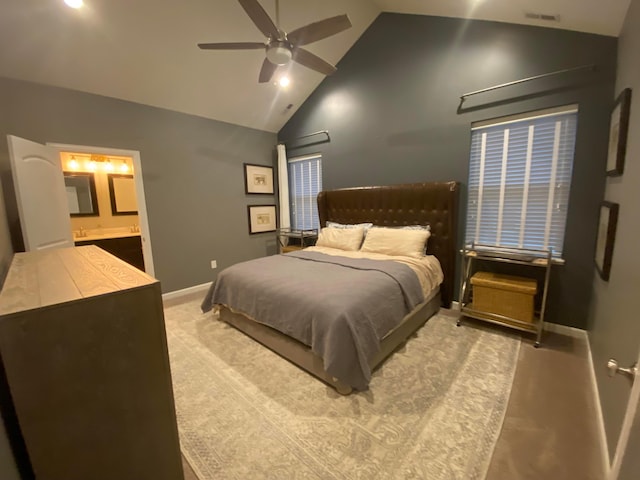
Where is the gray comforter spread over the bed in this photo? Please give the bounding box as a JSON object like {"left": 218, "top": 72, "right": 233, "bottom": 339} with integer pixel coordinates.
{"left": 202, "top": 251, "right": 424, "bottom": 390}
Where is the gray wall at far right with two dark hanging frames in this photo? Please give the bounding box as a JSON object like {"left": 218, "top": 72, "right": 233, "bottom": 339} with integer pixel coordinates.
{"left": 589, "top": 0, "right": 640, "bottom": 462}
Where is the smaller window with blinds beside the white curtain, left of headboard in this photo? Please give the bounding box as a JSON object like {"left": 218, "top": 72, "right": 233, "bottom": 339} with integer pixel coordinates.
{"left": 288, "top": 153, "right": 322, "bottom": 230}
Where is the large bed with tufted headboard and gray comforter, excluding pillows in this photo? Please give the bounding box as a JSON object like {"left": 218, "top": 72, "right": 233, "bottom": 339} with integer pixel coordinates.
{"left": 203, "top": 182, "right": 459, "bottom": 395}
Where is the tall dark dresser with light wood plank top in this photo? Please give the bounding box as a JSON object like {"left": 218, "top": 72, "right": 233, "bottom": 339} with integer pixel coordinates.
{"left": 0, "top": 246, "right": 183, "bottom": 480}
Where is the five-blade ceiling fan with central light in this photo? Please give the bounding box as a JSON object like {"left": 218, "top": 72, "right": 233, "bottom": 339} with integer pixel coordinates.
{"left": 198, "top": 0, "right": 351, "bottom": 83}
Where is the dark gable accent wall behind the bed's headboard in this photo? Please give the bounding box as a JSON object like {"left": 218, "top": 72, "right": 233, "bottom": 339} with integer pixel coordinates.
{"left": 278, "top": 13, "right": 617, "bottom": 328}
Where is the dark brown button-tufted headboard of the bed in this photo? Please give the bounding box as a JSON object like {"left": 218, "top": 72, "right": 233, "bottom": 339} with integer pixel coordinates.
{"left": 318, "top": 182, "right": 459, "bottom": 308}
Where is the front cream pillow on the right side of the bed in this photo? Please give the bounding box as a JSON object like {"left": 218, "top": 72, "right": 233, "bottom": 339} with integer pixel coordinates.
{"left": 360, "top": 227, "right": 431, "bottom": 258}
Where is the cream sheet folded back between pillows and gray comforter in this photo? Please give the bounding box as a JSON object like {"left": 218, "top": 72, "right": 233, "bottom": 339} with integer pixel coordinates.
{"left": 305, "top": 247, "right": 444, "bottom": 298}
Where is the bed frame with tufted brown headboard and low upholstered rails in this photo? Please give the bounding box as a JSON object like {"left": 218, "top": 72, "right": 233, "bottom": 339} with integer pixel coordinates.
{"left": 220, "top": 182, "right": 459, "bottom": 395}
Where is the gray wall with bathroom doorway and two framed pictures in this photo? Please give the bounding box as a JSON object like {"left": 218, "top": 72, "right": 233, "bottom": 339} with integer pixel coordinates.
{"left": 0, "top": 78, "right": 276, "bottom": 292}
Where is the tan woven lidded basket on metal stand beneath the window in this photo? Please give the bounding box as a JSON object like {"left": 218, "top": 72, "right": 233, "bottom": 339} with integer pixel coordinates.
{"left": 471, "top": 272, "right": 538, "bottom": 322}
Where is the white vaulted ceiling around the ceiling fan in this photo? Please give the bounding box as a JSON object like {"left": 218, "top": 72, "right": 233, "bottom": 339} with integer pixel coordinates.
{"left": 0, "top": 0, "right": 630, "bottom": 132}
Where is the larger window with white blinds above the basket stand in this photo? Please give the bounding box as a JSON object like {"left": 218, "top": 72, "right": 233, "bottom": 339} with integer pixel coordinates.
{"left": 466, "top": 105, "right": 578, "bottom": 258}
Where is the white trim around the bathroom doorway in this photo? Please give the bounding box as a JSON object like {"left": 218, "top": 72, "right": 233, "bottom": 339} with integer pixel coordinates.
{"left": 47, "top": 142, "right": 155, "bottom": 277}
